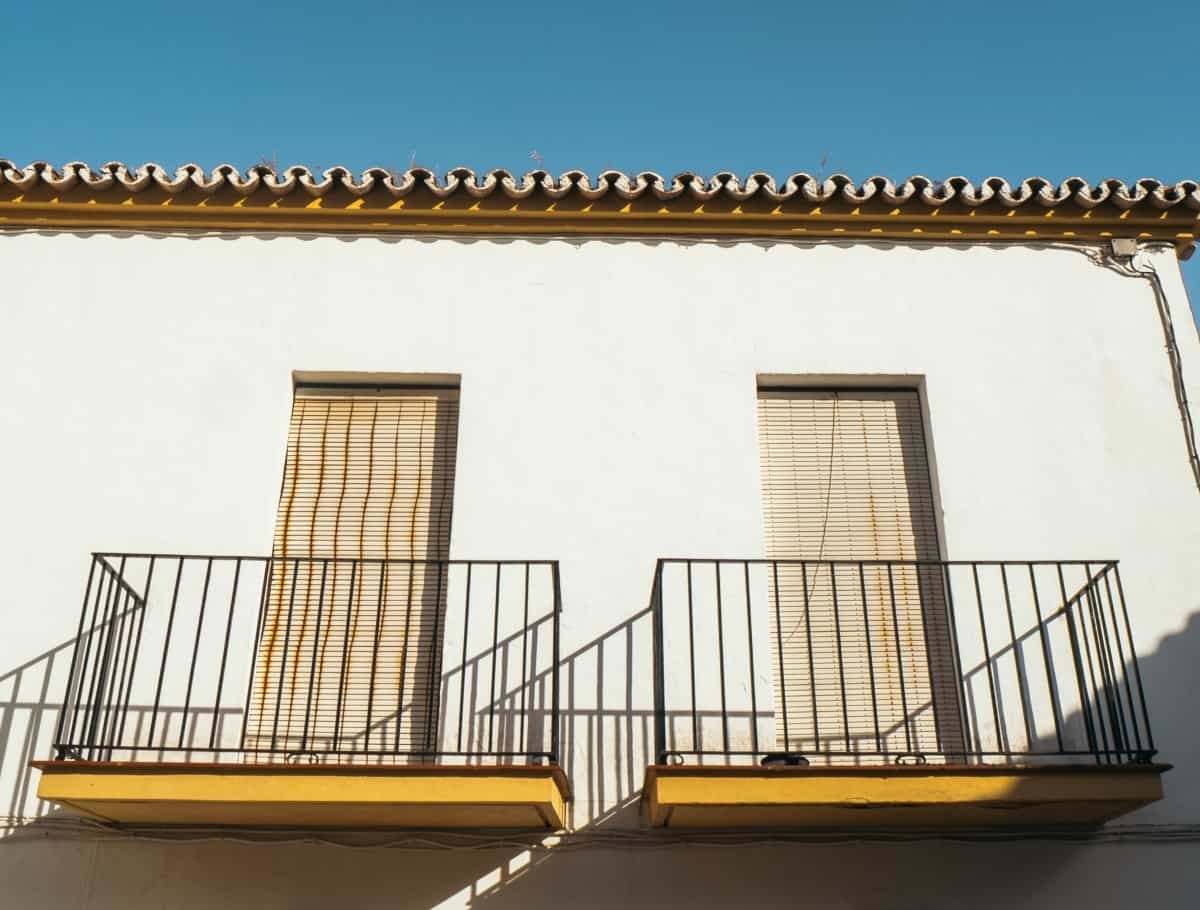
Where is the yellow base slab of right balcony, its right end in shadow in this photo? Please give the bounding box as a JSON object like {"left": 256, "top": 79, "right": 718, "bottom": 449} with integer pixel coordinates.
{"left": 642, "top": 765, "right": 1169, "bottom": 828}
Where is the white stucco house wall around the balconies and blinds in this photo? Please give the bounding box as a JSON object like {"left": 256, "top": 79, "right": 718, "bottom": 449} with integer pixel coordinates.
{"left": 0, "top": 234, "right": 1200, "bottom": 906}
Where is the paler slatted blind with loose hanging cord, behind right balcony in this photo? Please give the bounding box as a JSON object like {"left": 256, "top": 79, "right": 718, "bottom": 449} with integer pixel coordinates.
{"left": 758, "top": 389, "right": 962, "bottom": 762}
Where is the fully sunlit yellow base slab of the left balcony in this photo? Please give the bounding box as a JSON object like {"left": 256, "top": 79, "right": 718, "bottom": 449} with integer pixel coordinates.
{"left": 35, "top": 761, "right": 569, "bottom": 828}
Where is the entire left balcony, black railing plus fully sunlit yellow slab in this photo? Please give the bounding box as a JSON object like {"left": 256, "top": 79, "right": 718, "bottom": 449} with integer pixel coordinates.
{"left": 35, "top": 553, "right": 570, "bottom": 828}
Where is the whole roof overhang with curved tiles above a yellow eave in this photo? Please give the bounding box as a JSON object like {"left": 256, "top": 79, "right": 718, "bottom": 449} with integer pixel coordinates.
{"left": 0, "top": 160, "right": 1200, "bottom": 255}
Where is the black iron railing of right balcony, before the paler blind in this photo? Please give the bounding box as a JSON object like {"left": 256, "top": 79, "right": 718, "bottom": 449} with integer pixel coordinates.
{"left": 650, "top": 558, "right": 1154, "bottom": 765}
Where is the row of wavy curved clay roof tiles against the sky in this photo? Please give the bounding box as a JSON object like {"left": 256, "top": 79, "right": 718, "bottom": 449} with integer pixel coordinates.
{"left": 7, "top": 158, "right": 1200, "bottom": 211}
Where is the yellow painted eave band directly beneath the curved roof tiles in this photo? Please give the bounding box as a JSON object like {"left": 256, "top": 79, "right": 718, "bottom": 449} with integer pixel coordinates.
{"left": 0, "top": 191, "right": 1200, "bottom": 249}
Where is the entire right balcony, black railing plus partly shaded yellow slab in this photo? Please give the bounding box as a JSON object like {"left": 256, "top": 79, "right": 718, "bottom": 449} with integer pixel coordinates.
{"left": 642, "top": 559, "right": 1166, "bottom": 828}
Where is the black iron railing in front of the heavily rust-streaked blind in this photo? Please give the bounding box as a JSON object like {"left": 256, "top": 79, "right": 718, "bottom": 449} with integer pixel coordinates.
{"left": 54, "top": 553, "right": 562, "bottom": 764}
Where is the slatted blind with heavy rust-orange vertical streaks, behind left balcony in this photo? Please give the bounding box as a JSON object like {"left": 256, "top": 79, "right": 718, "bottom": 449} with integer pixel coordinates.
{"left": 246, "top": 389, "right": 458, "bottom": 758}
